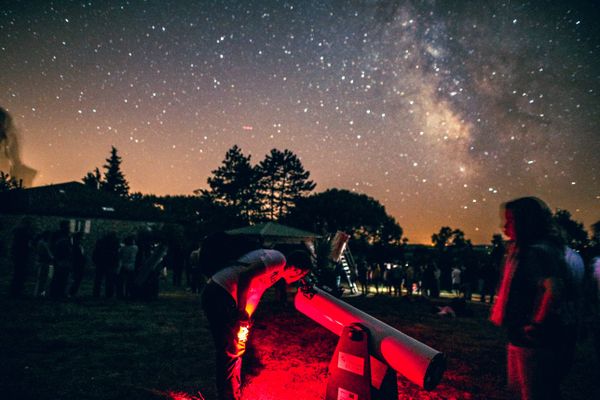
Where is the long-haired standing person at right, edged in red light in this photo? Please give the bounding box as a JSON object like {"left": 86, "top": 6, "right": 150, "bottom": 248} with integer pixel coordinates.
{"left": 490, "top": 197, "right": 569, "bottom": 400}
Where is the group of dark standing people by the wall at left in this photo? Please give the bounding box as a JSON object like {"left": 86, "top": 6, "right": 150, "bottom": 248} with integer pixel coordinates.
{"left": 9, "top": 218, "right": 176, "bottom": 300}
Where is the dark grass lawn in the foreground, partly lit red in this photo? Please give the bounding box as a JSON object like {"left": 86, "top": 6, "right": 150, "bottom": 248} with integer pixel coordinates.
{"left": 0, "top": 268, "right": 600, "bottom": 400}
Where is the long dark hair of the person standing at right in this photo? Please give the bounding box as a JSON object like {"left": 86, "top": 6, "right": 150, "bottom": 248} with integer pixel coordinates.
{"left": 503, "top": 197, "right": 562, "bottom": 247}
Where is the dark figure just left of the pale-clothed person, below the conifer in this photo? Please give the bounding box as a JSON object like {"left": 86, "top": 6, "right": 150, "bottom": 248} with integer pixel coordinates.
{"left": 92, "top": 232, "right": 119, "bottom": 298}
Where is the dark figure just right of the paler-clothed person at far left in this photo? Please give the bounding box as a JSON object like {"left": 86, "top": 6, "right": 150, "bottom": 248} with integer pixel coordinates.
{"left": 50, "top": 221, "right": 73, "bottom": 299}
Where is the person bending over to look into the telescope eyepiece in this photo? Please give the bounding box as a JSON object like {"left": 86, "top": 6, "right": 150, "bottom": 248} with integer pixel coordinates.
{"left": 202, "top": 249, "right": 312, "bottom": 400}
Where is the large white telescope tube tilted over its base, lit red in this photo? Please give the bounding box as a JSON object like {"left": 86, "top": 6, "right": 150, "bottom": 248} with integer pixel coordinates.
{"left": 294, "top": 287, "right": 445, "bottom": 390}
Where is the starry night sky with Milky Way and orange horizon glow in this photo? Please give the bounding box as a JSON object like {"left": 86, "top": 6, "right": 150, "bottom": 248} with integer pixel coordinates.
{"left": 0, "top": 0, "right": 600, "bottom": 243}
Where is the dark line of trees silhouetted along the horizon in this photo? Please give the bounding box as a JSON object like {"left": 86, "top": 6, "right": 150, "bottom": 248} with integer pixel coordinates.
{"left": 0, "top": 145, "right": 600, "bottom": 264}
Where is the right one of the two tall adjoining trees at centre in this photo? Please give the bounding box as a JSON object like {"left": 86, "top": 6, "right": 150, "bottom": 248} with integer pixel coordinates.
{"left": 257, "top": 149, "right": 316, "bottom": 220}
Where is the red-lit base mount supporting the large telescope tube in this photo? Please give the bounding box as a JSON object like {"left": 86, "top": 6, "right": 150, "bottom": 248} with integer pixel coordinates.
{"left": 325, "top": 323, "right": 398, "bottom": 400}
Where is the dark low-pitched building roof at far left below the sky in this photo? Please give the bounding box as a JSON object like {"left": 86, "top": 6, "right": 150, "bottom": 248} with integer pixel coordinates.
{"left": 0, "top": 181, "right": 160, "bottom": 220}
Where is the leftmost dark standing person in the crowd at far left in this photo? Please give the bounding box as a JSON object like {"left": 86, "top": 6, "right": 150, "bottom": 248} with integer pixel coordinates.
{"left": 10, "top": 218, "right": 34, "bottom": 298}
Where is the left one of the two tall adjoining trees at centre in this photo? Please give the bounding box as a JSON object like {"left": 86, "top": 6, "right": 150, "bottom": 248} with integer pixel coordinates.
{"left": 200, "top": 145, "right": 259, "bottom": 221}
